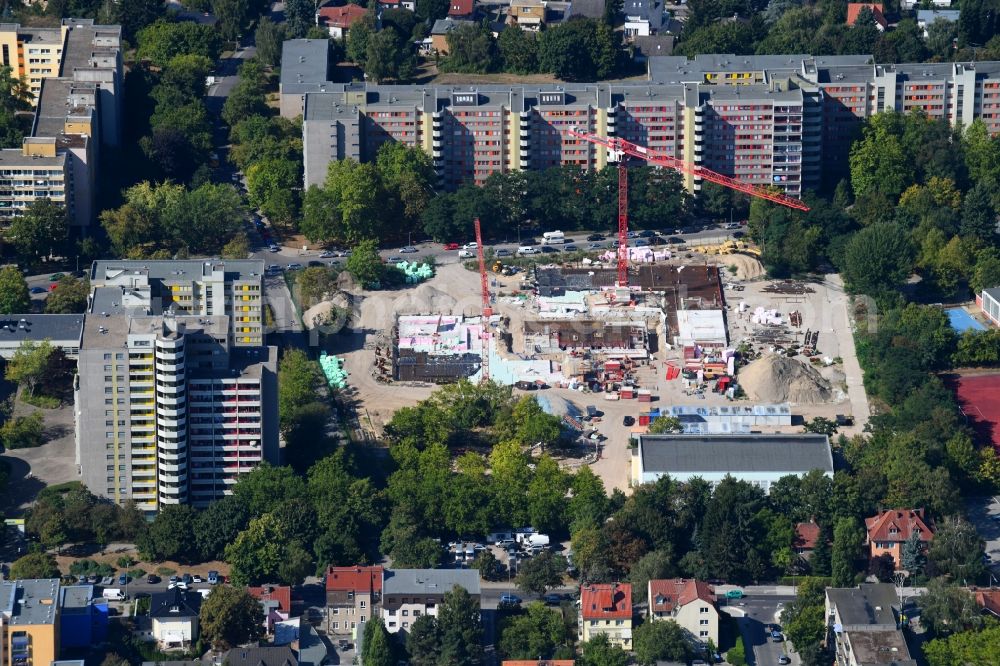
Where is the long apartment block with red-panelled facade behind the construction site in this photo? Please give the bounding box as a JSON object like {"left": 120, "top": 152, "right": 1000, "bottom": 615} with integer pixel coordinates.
{"left": 281, "top": 40, "right": 1000, "bottom": 196}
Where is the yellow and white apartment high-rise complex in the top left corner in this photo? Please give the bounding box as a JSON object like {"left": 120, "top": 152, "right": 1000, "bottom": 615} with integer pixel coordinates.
{"left": 0, "top": 19, "right": 122, "bottom": 230}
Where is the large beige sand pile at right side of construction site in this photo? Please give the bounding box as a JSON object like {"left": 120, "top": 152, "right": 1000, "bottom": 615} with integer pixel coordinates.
{"left": 739, "top": 354, "right": 833, "bottom": 405}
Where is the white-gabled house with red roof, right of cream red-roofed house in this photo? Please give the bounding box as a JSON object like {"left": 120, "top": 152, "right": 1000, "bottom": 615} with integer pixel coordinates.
{"left": 647, "top": 578, "right": 719, "bottom": 645}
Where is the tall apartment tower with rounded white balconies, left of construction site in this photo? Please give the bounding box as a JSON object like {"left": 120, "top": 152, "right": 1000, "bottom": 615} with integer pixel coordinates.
{"left": 75, "top": 261, "right": 278, "bottom": 513}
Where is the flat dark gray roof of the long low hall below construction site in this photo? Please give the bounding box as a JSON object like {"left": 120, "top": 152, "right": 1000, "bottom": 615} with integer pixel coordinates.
{"left": 639, "top": 434, "right": 833, "bottom": 474}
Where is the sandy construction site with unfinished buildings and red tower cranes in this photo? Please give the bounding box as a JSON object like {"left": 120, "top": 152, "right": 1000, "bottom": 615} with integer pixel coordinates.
{"left": 318, "top": 131, "right": 868, "bottom": 490}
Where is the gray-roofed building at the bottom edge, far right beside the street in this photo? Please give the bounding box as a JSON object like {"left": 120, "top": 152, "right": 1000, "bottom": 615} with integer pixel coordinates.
{"left": 826, "top": 583, "right": 917, "bottom": 666}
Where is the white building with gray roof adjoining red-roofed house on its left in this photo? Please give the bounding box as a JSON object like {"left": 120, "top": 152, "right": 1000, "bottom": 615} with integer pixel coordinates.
{"left": 378, "top": 569, "right": 480, "bottom": 634}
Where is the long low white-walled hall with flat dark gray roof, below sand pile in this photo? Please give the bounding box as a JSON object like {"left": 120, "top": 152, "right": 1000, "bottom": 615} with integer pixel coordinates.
{"left": 632, "top": 433, "right": 833, "bottom": 492}
